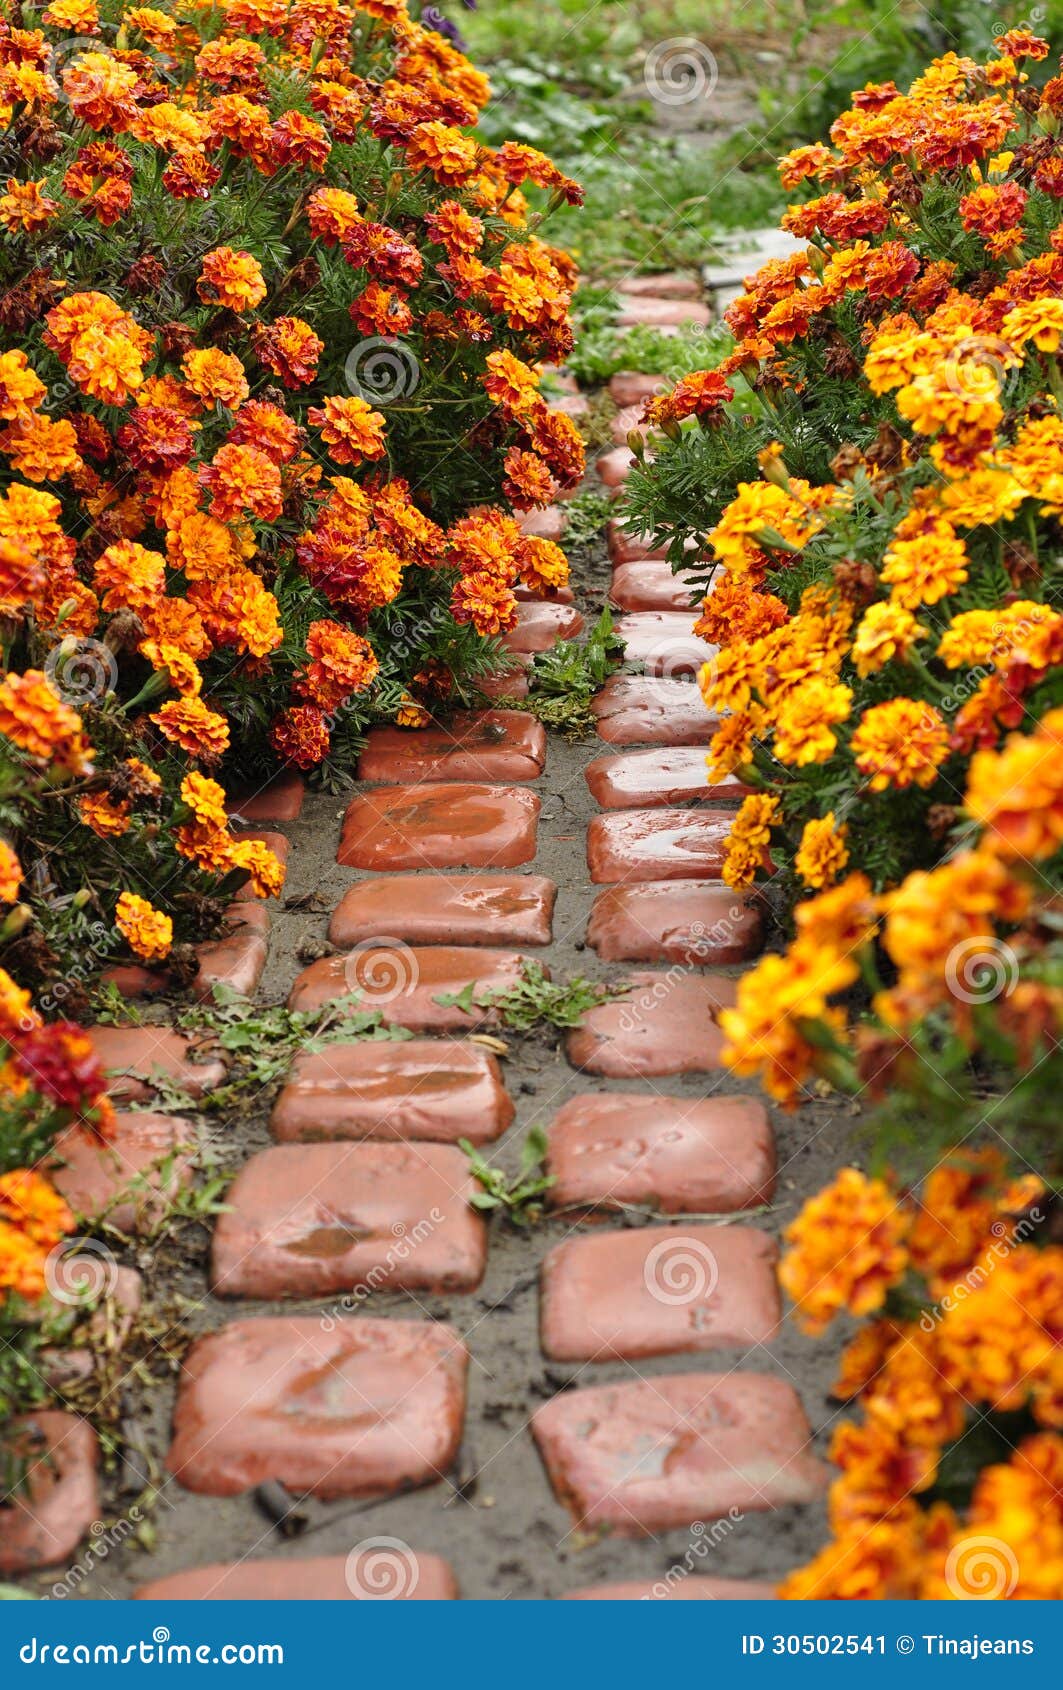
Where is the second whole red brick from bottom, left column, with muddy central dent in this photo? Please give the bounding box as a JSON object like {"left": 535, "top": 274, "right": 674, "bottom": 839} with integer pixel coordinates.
{"left": 211, "top": 1144, "right": 487, "bottom": 1310}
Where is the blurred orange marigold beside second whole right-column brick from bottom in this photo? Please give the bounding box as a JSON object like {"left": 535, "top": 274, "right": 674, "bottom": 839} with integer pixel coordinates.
{"left": 779, "top": 1168, "right": 911, "bottom": 1333}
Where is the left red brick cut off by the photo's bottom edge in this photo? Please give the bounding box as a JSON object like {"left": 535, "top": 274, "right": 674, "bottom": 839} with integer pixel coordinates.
{"left": 134, "top": 1538, "right": 458, "bottom": 1602}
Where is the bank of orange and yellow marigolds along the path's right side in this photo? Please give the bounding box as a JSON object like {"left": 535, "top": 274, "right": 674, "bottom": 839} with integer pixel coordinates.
{"left": 629, "top": 30, "right": 1063, "bottom": 1595}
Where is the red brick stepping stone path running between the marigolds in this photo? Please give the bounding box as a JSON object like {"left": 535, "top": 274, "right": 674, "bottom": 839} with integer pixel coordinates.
{"left": 18, "top": 329, "right": 826, "bottom": 1600}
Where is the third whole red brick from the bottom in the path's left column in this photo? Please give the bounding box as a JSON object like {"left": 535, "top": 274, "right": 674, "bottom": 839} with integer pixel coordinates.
{"left": 270, "top": 1039, "right": 514, "bottom": 1144}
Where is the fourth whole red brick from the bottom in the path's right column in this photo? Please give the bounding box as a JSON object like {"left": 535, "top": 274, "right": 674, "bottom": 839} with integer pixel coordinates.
{"left": 564, "top": 973, "right": 735, "bottom": 1080}
